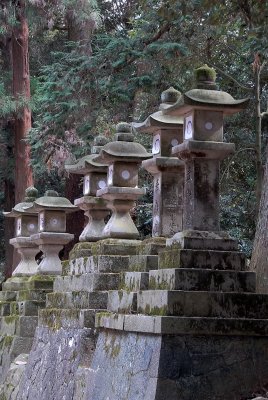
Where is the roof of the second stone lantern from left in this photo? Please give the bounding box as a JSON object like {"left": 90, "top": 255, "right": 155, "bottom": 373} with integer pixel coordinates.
{"left": 33, "top": 190, "right": 78, "bottom": 213}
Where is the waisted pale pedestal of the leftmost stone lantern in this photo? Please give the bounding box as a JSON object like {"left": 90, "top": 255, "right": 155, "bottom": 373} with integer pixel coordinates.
{"left": 9, "top": 237, "right": 39, "bottom": 276}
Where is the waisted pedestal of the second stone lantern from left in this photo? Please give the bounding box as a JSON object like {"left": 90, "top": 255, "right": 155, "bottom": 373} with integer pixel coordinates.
{"left": 31, "top": 232, "right": 74, "bottom": 275}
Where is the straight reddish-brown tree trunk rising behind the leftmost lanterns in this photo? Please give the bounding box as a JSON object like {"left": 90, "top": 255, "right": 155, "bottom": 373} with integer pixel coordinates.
{"left": 11, "top": 1, "right": 33, "bottom": 203}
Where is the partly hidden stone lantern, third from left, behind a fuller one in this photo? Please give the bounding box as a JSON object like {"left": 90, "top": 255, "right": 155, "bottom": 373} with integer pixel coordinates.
{"left": 65, "top": 136, "right": 110, "bottom": 242}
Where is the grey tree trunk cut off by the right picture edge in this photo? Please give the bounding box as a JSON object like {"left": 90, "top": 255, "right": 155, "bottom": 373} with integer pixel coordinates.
{"left": 250, "top": 148, "right": 268, "bottom": 293}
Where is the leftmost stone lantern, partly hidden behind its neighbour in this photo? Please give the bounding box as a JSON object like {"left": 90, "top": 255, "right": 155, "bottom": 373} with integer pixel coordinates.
{"left": 4, "top": 187, "right": 39, "bottom": 276}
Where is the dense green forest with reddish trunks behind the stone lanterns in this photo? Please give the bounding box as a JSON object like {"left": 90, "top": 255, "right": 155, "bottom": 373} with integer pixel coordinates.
{"left": 0, "top": 0, "right": 268, "bottom": 278}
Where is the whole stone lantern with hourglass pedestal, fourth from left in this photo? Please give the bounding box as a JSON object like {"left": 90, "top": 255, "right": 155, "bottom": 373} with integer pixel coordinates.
{"left": 97, "top": 123, "right": 151, "bottom": 239}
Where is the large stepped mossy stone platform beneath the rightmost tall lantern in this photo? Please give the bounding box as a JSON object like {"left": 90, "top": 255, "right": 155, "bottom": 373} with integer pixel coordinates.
{"left": 92, "top": 242, "right": 268, "bottom": 400}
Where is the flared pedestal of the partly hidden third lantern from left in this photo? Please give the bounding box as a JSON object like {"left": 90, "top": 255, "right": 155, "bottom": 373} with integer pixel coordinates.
{"left": 74, "top": 196, "right": 110, "bottom": 242}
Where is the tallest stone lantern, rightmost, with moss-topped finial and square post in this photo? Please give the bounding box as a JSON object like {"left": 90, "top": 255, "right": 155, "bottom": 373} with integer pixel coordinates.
{"left": 164, "top": 65, "right": 249, "bottom": 247}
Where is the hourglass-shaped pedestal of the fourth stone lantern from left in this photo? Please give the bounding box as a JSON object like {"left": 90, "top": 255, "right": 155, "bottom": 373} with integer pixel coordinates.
{"left": 97, "top": 186, "right": 145, "bottom": 239}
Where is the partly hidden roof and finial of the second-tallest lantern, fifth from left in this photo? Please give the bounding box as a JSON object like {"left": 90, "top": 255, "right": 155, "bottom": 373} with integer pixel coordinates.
{"left": 132, "top": 87, "right": 183, "bottom": 133}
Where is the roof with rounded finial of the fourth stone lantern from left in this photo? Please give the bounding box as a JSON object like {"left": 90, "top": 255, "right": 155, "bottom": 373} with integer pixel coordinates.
{"left": 98, "top": 122, "right": 152, "bottom": 164}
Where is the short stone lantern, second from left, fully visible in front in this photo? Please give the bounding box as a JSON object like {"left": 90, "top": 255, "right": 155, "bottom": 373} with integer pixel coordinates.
{"left": 31, "top": 190, "right": 78, "bottom": 275}
